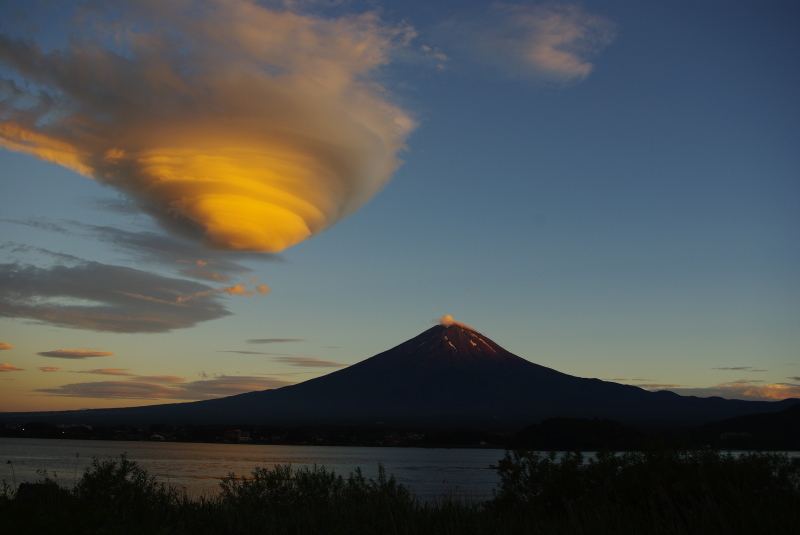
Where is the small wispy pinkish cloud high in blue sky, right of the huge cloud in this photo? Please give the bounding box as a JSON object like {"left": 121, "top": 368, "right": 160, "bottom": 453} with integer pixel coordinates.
{"left": 438, "top": 3, "right": 615, "bottom": 84}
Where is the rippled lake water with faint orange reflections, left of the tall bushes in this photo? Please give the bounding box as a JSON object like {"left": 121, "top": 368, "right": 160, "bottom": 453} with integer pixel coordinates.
{"left": 0, "top": 438, "right": 504, "bottom": 500}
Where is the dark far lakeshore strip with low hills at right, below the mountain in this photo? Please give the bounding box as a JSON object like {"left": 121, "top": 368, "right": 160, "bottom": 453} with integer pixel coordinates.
{"left": 0, "top": 403, "right": 800, "bottom": 451}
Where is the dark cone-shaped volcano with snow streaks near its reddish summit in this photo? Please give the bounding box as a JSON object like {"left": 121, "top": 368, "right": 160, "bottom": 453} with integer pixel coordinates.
{"left": 0, "top": 324, "right": 800, "bottom": 429}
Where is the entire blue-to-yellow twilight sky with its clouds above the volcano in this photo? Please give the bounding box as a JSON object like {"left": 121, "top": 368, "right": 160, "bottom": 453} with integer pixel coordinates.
{"left": 0, "top": 0, "right": 800, "bottom": 411}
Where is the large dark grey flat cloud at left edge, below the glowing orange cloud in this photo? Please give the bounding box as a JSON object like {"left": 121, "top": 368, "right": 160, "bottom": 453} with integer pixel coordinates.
{"left": 0, "top": 262, "right": 230, "bottom": 332}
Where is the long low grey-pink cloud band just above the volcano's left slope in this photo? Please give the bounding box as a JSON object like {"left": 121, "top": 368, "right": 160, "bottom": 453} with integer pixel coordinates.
{"left": 36, "top": 375, "right": 293, "bottom": 401}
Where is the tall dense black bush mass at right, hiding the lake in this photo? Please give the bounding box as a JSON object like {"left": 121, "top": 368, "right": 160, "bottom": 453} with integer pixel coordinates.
{"left": 492, "top": 450, "right": 800, "bottom": 533}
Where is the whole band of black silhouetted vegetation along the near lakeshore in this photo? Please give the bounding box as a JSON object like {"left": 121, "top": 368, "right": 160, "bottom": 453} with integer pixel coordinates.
{"left": 0, "top": 450, "right": 800, "bottom": 535}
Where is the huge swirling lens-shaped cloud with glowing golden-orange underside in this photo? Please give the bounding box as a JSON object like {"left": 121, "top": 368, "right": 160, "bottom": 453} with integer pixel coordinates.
{"left": 0, "top": 0, "right": 415, "bottom": 252}
